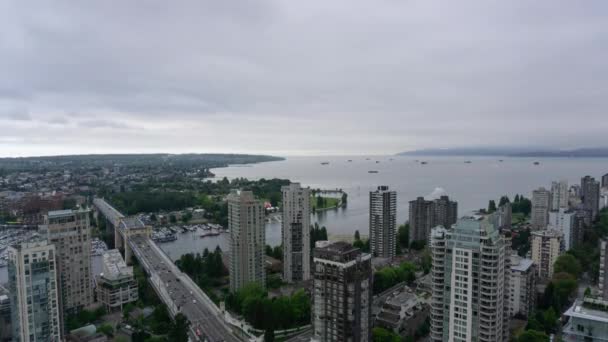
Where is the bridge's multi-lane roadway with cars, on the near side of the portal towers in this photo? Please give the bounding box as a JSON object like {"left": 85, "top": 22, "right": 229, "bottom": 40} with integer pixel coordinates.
{"left": 130, "top": 237, "right": 241, "bottom": 342}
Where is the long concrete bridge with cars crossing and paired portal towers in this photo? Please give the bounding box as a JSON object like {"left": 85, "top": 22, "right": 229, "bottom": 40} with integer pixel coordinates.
{"left": 93, "top": 198, "right": 249, "bottom": 342}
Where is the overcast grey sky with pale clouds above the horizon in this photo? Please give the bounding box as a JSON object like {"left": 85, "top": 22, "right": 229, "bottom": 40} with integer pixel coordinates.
{"left": 0, "top": 0, "right": 608, "bottom": 156}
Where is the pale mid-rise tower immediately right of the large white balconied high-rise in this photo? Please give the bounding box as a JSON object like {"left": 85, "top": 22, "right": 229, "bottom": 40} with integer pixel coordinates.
{"left": 509, "top": 255, "right": 536, "bottom": 318}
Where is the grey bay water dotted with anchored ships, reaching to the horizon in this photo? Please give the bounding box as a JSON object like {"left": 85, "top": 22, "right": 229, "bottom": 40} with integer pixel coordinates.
{"left": 212, "top": 156, "right": 608, "bottom": 239}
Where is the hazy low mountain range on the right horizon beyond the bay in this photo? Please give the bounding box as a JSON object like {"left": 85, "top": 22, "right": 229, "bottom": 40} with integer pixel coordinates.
{"left": 397, "top": 147, "right": 608, "bottom": 158}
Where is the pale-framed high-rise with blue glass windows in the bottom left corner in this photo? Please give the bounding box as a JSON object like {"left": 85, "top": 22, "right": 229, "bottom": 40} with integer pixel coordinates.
{"left": 8, "top": 240, "right": 62, "bottom": 342}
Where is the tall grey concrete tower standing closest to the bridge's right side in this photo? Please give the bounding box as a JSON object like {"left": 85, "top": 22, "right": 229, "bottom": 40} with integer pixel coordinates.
{"left": 228, "top": 190, "right": 266, "bottom": 292}
